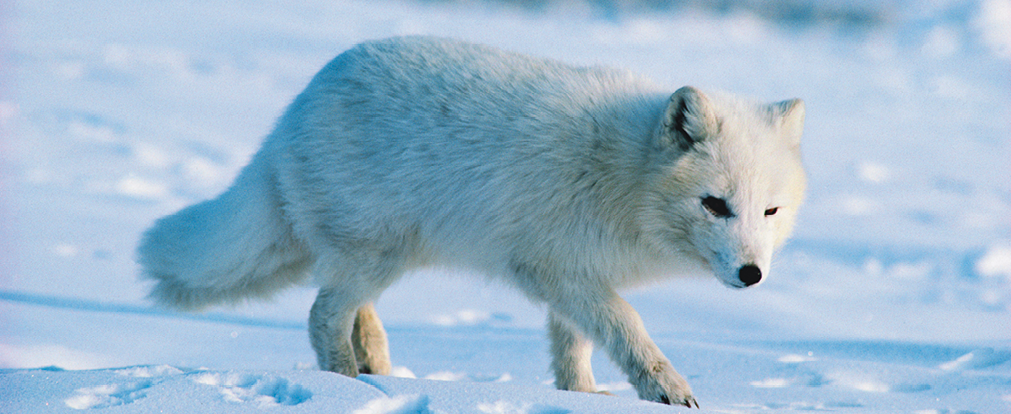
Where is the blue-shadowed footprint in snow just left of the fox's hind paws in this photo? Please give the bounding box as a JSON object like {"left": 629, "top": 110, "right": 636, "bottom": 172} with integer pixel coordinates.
{"left": 193, "top": 372, "right": 312, "bottom": 408}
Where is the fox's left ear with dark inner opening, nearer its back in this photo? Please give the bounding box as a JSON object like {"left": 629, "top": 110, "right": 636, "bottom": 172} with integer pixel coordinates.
{"left": 660, "top": 86, "right": 720, "bottom": 151}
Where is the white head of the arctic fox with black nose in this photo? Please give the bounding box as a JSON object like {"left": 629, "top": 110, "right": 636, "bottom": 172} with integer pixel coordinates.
{"left": 649, "top": 86, "right": 806, "bottom": 287}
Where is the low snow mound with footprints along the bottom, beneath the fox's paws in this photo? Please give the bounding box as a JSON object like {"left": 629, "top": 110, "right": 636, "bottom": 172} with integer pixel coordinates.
{"left": 0, "top": 365, "right": 687, "bottom": 414}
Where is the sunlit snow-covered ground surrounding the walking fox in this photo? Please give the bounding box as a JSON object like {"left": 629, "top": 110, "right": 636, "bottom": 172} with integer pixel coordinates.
{"left": 0, "top": 0, "right": 1011, "bottom": 413}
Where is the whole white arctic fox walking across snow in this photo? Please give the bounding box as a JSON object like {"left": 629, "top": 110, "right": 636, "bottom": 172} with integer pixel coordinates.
{"left": 139, "top": 37, "right": 806, "bottom": 407}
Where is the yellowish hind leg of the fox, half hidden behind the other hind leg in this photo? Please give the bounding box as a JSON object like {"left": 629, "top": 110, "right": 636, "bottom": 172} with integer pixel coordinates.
{"left": 351, "top": 303, "right": 390, "bottom": 376}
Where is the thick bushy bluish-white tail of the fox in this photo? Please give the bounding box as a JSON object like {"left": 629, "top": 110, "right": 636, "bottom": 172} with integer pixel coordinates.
{"left": 137, "top": 154, "right": 312, "bottom": 310}
